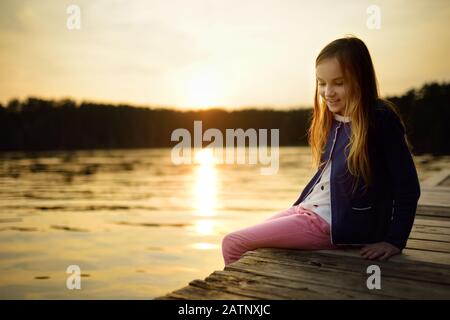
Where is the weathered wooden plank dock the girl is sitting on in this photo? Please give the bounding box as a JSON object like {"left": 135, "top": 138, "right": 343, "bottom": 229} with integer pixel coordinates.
{"left": 155, "top": 171, "right": 450, "bottom": 300}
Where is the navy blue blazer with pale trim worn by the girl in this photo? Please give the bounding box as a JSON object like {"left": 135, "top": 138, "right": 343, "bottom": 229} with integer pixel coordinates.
{"left": 293, "top": 100, "right": 420, "bottom": 249}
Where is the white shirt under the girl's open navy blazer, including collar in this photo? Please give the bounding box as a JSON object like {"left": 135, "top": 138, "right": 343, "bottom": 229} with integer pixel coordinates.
{"left": 299, "top": 113, "right": 350, "bottom": 225}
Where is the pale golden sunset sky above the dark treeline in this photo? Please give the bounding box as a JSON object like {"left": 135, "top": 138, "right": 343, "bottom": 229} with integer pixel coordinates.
{"left": 0, "top": 0, "right": 450, "bottom": 109}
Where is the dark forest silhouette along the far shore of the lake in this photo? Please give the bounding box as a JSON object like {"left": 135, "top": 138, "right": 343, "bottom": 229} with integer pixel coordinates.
{"left": 0, "top": 83, "right": 450, "bottom": 155}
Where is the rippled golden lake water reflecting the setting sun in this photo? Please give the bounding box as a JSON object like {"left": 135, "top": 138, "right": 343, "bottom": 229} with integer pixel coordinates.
{"left": 0, "top": 147, "right": 450, "bottom": 299}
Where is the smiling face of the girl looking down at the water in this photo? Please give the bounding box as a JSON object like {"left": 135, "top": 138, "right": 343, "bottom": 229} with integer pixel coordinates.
{"left": 316, "top": 58, "right": 347, "bottom": 115}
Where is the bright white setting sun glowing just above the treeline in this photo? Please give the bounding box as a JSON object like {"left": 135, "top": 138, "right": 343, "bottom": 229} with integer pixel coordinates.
{"left": 188, "top": 69, "right": 223, "bottom": 108}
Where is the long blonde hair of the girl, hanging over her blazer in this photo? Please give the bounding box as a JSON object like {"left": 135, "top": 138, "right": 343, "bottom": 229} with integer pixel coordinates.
{"left": 308, "top": 36, "right": 403, "bottom": 191}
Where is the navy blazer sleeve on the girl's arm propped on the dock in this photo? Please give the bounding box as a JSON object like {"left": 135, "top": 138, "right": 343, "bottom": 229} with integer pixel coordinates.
{"left": 381, "top": 110, "right": 420, "bottom": 250}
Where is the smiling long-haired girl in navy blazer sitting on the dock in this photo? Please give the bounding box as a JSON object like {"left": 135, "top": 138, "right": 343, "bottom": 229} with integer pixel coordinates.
{"left": 222, "top": 37, "right": 420, "bottom": 265}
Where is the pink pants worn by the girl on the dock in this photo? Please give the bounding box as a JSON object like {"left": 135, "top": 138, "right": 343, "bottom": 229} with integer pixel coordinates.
{"left": 222, "top": 206, "right": 336, "bottom": 265}
